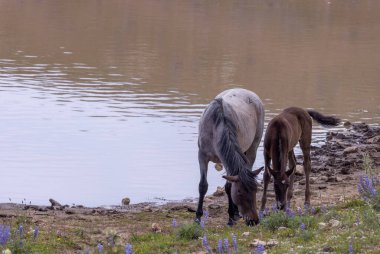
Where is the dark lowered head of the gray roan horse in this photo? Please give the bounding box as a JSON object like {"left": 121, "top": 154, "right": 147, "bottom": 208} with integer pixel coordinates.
{"left": 223, "top": 168, "right": 263, "bottom": 226}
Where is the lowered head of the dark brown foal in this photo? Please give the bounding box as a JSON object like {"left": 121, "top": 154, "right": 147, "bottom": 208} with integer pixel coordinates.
{"left": 269, "top": 168, "right": 293, "bottom": 210}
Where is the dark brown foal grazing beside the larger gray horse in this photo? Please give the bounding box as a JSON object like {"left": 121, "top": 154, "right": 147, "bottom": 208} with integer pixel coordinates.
{"left": 261, "top": 107, "right": 340, "bottom": 211}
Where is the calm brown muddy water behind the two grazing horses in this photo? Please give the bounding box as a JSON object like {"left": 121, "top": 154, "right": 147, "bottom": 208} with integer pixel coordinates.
{"left": 0, "top": 0, "right": 380, "bottom": 206}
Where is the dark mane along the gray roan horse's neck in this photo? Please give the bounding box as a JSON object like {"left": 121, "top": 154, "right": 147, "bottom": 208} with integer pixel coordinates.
{"left": 209, "top": 98, "right": 257, "bottom": 189}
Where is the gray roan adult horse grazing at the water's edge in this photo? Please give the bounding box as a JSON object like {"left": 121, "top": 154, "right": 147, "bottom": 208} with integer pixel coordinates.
{"left": 195, "top": 88, "right": 264, "bottom": 225}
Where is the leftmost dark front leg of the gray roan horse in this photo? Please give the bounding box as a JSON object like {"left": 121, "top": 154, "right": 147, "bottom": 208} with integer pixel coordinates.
{"left": 195, "top": 151, "right": 209, "bottom": 223}
